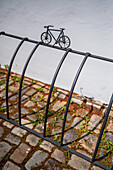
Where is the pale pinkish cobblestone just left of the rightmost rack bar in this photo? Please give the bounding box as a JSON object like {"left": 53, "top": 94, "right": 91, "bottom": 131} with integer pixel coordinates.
{"left": 89, "top": 115, "right": 101, "bottom": 129}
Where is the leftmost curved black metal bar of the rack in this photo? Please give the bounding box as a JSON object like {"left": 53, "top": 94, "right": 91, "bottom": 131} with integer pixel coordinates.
{"left": 6, "top": 38, "right": 26, "bottom": 119}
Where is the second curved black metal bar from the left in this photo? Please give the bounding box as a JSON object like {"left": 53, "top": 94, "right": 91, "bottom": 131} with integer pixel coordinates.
{"left": 18, "top": 43, "right": 40, "bottom": 125}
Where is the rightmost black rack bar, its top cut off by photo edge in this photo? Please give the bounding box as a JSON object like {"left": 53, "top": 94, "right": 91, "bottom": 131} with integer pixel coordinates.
{"left": 92, "top": 94, "right": 113, "bottom": 162}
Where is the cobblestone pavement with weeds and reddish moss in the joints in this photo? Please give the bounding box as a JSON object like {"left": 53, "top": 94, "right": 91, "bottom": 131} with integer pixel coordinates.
{"left": 0, "top": 69, "right": 113, "bottom": 170}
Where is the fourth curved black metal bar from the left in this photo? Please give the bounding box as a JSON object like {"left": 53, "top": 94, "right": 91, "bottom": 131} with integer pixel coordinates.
{"left": 60, "top": 53, "right": 91, "bottom": 145}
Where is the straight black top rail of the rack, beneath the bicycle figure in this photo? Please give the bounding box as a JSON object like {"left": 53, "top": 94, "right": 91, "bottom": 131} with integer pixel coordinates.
{"left": 1, "top": 32, "right": 113, "bottom": 62}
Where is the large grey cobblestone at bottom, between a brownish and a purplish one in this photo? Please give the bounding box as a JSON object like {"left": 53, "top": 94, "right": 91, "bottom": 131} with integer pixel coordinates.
{"left": 25, "top": 150, "right": 48, "bottom": 170}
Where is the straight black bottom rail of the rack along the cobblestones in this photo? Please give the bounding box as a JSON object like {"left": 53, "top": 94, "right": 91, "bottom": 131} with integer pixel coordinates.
{"left": 0, "top": 115, "right": 109, "bottom": 170}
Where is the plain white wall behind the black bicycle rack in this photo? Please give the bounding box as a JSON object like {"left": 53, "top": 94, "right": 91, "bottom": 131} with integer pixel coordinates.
{"left": 0, "top": 0, "right": 113, "bottom": 102}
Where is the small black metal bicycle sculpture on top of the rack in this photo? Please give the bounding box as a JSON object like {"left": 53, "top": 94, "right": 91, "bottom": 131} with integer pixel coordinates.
{"left": 41, "top": 25, "right": 71, "bottom": 49}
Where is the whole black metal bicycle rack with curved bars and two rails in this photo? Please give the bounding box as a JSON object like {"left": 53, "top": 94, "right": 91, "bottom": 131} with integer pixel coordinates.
{"left": 0, "top": 32, "right": 113, "bottom": 169}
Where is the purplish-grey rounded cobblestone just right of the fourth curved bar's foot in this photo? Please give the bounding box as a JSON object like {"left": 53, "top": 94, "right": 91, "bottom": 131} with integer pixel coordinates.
{"left": 63, "top": 129, "right": 78, "bottom": 144}
